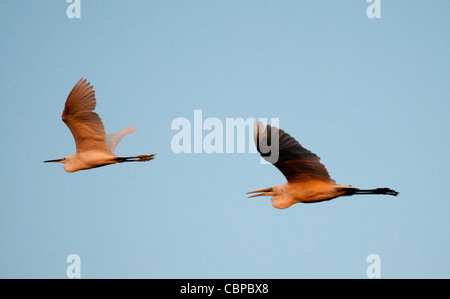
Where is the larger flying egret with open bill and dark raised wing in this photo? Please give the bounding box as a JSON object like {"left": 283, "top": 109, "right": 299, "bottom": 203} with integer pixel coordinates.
{"left": 247, "top": 121, "right": 398, "bottom": 209}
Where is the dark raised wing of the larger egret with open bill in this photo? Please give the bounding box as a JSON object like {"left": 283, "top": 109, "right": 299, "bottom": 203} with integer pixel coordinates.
{"left": 254, "top": 122, "right": 334, "bottom": 182}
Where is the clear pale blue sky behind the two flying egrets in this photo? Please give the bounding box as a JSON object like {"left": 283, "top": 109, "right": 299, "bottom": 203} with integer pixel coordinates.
{"left": 0, "top": 0, "right": 450, "bottom": 278}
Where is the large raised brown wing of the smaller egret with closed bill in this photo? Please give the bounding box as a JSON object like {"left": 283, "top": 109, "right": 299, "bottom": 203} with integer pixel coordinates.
{"left": 62, "top": 78, "right": 110, "bottom": 152}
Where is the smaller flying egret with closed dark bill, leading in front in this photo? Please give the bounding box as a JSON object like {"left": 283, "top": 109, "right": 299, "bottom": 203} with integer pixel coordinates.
{"left": 44, "top": 78, "right": 155, "bottom": 172}
